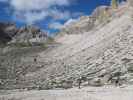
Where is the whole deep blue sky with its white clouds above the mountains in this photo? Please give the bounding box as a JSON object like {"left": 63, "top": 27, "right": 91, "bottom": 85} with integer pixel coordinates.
{"left": 0, "top": 0, "right": 120, "bottom": 32}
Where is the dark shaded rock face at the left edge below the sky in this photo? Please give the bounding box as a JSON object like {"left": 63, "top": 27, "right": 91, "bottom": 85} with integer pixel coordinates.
{"left": 0, "top": 23, "right": 17, "bottom": 43}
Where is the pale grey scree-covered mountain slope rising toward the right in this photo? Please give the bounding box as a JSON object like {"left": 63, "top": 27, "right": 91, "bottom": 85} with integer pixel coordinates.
{"left": 0, "top": 3, "right": 133, "bottom": 89}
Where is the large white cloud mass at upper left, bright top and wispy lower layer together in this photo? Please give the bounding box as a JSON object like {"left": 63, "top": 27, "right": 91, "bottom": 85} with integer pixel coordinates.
{"left": 10, "top": 0, "right": 71, "bottom": 24}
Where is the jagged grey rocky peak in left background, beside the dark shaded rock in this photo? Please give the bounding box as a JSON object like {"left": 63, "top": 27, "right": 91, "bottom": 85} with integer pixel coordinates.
{"left": 10, "top": 26, "right": 48, "bottom": 44}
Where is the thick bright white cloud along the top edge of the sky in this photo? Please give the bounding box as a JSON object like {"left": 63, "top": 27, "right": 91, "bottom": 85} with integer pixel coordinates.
{"left": 10, "top": 0, "right": 69, "bottom": 11}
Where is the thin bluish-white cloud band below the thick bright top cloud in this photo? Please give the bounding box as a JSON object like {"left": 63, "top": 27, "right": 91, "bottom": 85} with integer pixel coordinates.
{"left": 14, "top": 9, "right": 72, "bottom": 24}
